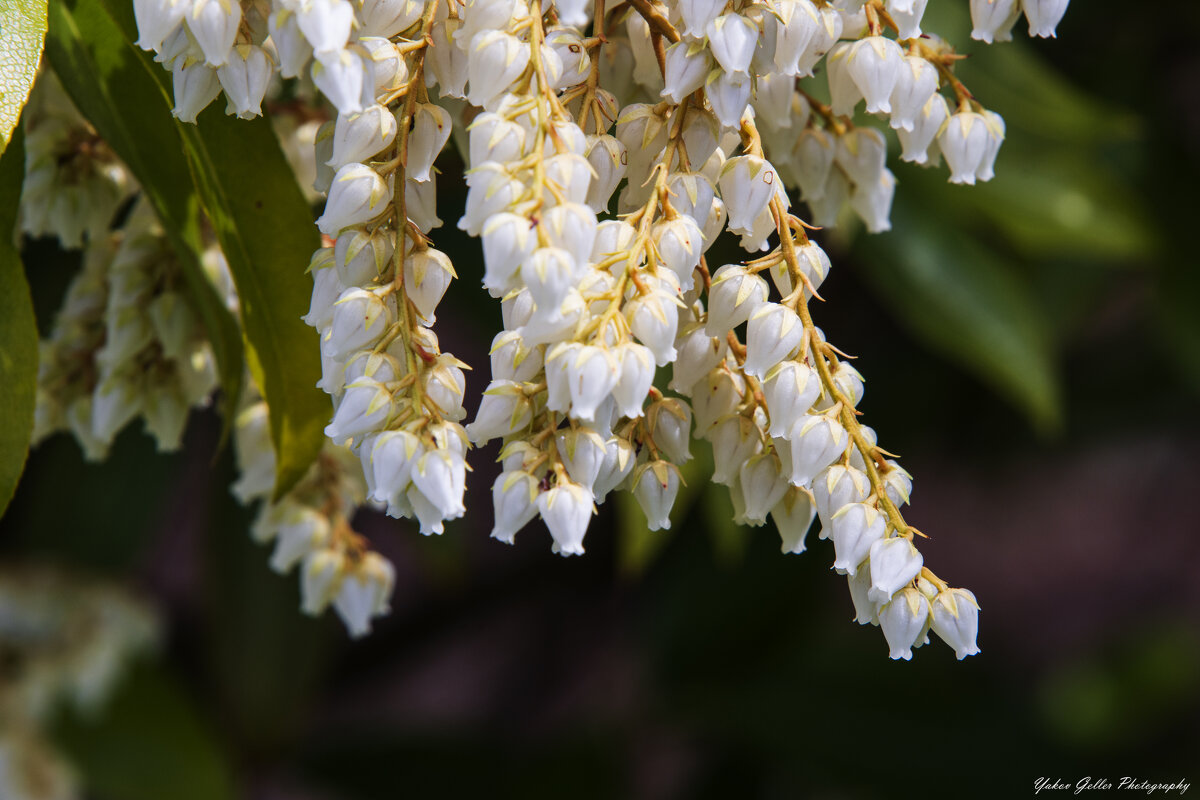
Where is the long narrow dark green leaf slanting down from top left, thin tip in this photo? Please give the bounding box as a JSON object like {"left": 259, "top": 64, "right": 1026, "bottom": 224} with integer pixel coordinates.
{"left": 46, "top": 0, "right": 244, "bottom": 425}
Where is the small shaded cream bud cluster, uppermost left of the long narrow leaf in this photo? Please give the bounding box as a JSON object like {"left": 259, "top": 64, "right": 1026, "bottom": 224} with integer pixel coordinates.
{"left": 20, "top": 71, "right": 133, "bottom": 248}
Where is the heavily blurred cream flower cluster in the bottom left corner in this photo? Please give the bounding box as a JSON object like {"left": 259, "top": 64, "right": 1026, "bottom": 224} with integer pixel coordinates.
{"left": 0, "top": 567, "right": 160, "bottom": 800}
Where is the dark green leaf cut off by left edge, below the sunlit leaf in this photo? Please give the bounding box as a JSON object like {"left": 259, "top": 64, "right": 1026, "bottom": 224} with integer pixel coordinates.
{"left": 0, "top": 128, "right": 37, "bottom": 515}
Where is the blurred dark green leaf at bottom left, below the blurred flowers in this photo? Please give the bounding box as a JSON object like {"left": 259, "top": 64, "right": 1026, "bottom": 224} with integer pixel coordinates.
{"left": 55, "top": 668, "right": 234, "bottom": 800}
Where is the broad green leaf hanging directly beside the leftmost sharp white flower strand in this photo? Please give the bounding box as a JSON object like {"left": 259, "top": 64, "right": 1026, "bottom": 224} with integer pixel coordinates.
{"left": 181, "top": 104, "right": 331, "bottom": 498}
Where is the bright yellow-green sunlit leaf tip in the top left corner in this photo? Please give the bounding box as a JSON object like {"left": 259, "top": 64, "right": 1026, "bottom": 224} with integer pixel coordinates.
{"left": 0, "top": 0, "right": 46, "bottom": 154}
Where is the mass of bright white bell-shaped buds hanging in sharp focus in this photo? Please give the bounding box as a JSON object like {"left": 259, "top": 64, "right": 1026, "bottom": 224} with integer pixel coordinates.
{"left": 117, "top": 0, "right": 1067, "bottom": 658}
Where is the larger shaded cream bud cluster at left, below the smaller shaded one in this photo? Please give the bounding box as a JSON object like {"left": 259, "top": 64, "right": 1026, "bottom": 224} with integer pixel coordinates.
{"left": 34, "top": 200, "right": 223, "bottom": 461}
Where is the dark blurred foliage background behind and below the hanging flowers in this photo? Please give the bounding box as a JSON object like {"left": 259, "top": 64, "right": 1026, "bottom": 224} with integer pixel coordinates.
{"left": 0, "top": 0, "right": 1200, "bottom": 800}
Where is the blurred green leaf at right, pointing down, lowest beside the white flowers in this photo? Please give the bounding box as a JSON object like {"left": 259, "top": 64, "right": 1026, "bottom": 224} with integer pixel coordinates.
{"left": 859, "top": 209, "right": 1062, "bottom": 431}
